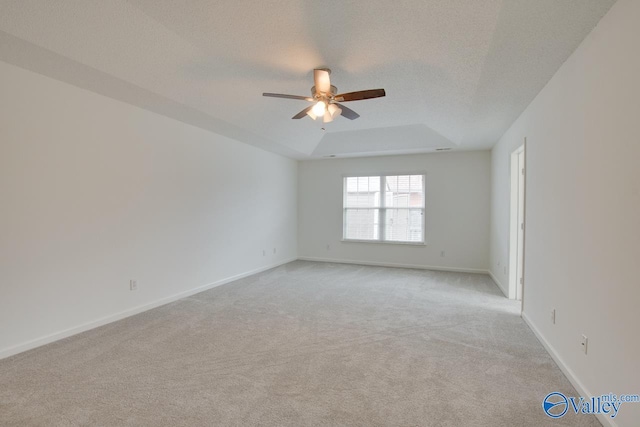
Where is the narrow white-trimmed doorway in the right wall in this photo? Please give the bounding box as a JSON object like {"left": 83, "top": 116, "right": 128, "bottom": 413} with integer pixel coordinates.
{"left": 509, "top": 143, "right": 527, "bottom": 301}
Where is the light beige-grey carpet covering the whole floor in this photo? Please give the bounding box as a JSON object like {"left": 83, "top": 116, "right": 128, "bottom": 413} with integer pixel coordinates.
{"left": 0, "top": 261, "right": 600, "bottom": 427}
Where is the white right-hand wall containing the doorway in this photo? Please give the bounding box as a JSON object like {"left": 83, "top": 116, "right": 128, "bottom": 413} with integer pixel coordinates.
{"left": 491, "top": 0, "right": 640, "bottom": 426}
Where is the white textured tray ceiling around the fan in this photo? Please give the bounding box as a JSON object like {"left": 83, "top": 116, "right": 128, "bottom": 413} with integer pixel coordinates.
{"left": 0, "top": 0, "right": 614, "bottom": 158}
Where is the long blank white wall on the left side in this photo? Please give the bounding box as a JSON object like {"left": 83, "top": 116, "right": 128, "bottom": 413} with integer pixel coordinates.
{"left": 0, "top": 62, "right": 297, "bottom": 357}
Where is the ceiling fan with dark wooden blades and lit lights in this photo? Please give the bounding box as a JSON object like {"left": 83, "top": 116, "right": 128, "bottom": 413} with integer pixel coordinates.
{"left": 262, "top": 68, "right": 386, "bottom": 123}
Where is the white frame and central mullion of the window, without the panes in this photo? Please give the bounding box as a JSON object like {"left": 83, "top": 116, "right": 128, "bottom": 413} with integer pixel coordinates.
{"left": 341, "top": 171, "right": 427, "bottom": 246}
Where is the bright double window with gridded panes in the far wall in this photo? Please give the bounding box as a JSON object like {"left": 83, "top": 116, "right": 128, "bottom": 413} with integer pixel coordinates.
{"left": 343, "top": 175, "right": 425, "bottom": 243}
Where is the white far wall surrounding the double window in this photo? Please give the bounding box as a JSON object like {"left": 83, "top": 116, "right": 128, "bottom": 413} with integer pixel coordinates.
{"left": 298, "top": 151, "right": 491, "bottom": 272}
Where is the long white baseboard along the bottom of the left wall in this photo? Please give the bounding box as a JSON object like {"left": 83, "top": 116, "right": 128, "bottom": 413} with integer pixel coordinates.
{"left": 0, "top": 258, "right": 297, "bottom": 359}
